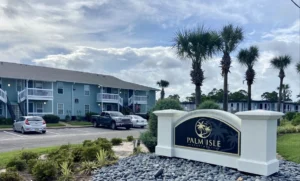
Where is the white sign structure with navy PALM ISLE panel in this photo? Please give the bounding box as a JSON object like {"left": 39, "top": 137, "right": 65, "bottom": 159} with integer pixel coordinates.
{"left": 154, "top": 110, "right": 283, "bottom": 176}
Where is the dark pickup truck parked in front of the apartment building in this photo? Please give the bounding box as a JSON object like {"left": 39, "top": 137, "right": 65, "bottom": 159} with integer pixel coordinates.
{"left": 92, "top": 111, "right": 132, "bottom": 129}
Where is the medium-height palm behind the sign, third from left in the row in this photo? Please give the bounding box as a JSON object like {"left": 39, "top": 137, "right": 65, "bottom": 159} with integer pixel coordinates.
{"left": 237, "top": 46, "right": 259, "bottom": 110}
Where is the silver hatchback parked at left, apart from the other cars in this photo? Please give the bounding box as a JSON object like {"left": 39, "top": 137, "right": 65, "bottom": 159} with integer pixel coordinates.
{"left": 13, "top": 116, "right": 46, "bottom": 134}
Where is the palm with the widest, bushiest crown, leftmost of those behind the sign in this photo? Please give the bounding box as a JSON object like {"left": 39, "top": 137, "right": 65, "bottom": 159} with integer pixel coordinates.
{"left": 174, "top": 26, "right": 221, "bottom": 106}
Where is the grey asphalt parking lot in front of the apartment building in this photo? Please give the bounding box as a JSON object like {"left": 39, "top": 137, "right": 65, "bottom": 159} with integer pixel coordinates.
{"left": 0, "top": 127, "right": 146, "bottom": 152}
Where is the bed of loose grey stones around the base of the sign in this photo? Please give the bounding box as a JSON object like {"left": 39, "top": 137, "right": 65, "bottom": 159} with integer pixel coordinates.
{"left": 92, "top": 154, "right": 300, "bottom": 181}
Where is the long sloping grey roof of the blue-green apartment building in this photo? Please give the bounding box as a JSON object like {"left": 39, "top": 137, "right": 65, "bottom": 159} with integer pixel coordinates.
{"left": 0, "top": 61, "right": 158, "bottom": 90}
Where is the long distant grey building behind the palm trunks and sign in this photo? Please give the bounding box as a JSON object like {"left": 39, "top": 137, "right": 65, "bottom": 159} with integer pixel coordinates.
{"left": 181, "top": 100, "right": 300, "bottom": 113}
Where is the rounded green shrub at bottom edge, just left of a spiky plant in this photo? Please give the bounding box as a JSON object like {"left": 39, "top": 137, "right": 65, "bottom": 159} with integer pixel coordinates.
{"left": 32, "top": 160, "right": 57, "bottom": 181}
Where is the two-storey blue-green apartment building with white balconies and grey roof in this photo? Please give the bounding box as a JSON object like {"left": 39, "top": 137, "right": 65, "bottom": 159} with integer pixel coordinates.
{"left": 0, "top": 62, "right": 158, "bottom": 119}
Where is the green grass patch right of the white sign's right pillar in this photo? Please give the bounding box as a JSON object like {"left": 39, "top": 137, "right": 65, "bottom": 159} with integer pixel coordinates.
{"left": 277, "top": 133, "right": 300, "bottom": 163}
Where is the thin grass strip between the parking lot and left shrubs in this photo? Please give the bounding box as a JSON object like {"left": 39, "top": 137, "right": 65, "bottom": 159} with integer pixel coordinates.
{"left": 0, "top": 144, "right": 79, "bottom": 169}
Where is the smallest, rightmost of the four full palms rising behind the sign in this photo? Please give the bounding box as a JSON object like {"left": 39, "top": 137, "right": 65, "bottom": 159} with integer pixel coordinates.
{"left": 271, "top": 55, "right": 291, "bottom": 112}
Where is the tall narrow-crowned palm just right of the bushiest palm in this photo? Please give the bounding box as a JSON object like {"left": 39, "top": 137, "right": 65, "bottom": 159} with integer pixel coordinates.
{"left": 220, "top": 24, "right": 244, "bottom": 111}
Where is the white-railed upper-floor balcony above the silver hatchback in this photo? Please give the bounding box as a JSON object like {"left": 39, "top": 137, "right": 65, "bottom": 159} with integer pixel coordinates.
{"left": 18, "top": 88, "right": 53, "bottom": 103}
